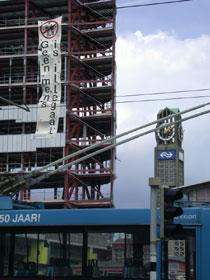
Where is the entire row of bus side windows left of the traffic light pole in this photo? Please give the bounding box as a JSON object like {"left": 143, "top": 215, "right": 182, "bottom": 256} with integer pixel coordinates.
{"left": 0, "top": 227, "right": 150, "bottom": 280}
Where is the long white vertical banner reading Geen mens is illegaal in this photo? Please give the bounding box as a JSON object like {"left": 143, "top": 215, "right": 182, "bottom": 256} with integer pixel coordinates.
{"left": 35, "top": 17, "right": 62, "bottom": 138}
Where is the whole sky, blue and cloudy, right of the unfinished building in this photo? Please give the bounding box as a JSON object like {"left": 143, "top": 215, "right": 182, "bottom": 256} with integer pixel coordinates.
{"left": 114, "top": 0, "right": 210, "bottom": 208}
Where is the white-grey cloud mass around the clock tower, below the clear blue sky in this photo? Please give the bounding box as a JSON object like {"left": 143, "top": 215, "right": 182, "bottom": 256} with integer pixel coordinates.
{"left": 115, "top": 31, "right": 210, "bottom": 207}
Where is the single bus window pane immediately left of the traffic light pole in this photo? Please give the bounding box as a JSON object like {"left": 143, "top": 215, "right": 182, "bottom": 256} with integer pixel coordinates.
{"left": 87, "top": 229, "right": 149, "bottom": 279}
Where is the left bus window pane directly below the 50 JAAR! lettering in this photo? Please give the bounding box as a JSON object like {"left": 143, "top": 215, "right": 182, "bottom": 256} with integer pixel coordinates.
{"left": 0, "top": 233, "right": 83, "bottom": 278}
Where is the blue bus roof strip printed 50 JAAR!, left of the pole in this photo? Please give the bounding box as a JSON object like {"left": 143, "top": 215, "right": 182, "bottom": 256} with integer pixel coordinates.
{"left": 0, "top": 209, "right": 150, "bottom": 227}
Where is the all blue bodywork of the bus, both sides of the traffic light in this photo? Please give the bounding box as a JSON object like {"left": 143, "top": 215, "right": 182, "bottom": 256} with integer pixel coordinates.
{"left": 0, "top": 208, "right": 210, "bottom": 280}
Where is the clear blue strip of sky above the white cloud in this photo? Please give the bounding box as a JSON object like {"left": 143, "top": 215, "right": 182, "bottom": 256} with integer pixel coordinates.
{"left": 117, "top": 0, "right": 210, "bottom": 38}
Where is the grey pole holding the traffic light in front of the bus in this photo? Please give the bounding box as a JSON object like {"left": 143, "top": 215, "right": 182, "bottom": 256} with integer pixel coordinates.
{"left": 149, "top": 177, "right": 160, "bottom": 280}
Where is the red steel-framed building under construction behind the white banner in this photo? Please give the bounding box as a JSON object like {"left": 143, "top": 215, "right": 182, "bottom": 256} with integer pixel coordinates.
{"left": 0, "top": 0, "right": 116, "bottom": 208}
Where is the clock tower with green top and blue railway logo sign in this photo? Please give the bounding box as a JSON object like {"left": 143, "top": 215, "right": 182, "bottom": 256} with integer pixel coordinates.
{"left": 155, "top": 108, "right": 184, "bottom": 187}
